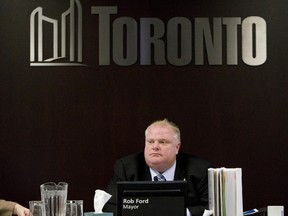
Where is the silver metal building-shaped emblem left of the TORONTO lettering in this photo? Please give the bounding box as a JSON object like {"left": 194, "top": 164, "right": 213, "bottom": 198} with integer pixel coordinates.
{"left": 30, "top": 0, "right": 86, "bottom": 66}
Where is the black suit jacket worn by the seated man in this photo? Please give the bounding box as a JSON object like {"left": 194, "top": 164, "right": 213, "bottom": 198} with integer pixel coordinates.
{"left": 104, "top": 152, "right": 211, "bottom": 216}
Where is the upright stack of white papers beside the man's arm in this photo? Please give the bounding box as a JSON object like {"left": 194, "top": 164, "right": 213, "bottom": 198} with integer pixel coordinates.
{"left": 208, "top": 168, "right": 243, "bottom": 216}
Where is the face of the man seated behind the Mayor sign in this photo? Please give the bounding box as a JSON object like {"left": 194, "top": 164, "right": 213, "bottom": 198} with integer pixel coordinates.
{"left": 144, "top": 125, "right": 180, "bottom": 172}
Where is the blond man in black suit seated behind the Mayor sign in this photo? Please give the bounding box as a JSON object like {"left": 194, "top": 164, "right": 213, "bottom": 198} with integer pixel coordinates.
{"left": 104, "top": 119, "right": 211, "bottom": 216}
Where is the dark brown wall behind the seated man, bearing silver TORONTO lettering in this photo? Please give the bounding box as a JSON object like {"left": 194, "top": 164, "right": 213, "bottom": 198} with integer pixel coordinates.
{"left": 0, "top": 0, "right": 288, "bottom": 214}
